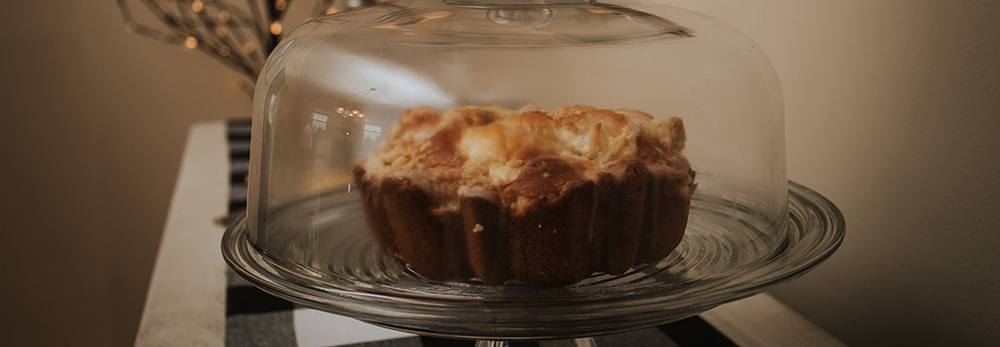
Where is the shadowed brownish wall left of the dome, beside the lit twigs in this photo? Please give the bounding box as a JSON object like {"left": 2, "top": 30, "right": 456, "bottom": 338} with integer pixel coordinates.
{"left": 0, "top": 0, "right": 250, "bottom": 346}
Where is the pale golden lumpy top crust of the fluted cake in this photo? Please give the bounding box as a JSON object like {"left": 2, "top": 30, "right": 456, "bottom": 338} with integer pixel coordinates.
{"left": 359, "top": 105, "right": 690, "bottom": 209}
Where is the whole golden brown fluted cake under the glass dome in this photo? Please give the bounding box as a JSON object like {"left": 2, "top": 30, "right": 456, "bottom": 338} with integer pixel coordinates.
{"left": 354, "top": 106, "right": 695, "bottom": 285}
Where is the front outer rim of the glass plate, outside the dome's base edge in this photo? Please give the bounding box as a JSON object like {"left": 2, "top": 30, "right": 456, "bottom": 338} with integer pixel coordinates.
{"left": 222, "top": 181, "right": 846, "bottom": 339}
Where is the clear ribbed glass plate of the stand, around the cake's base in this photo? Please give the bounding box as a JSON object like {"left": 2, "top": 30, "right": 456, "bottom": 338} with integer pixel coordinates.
{"left": 222, "top": 182, "right": 845, "bottom": 346}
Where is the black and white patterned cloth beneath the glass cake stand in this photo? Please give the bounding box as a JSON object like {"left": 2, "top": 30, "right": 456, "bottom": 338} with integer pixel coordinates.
{"left": 226, "top": 120, "right": 736, "bottom": 347}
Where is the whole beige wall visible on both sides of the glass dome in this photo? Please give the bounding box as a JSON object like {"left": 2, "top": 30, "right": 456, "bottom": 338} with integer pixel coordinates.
{"left": 0, "top": 0, "right": 1000, "bottom": 346}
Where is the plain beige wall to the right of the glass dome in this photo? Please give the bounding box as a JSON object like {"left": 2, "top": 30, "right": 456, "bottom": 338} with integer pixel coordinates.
{"left": 664, "top": 0, "right": 1000, "bottom": 346}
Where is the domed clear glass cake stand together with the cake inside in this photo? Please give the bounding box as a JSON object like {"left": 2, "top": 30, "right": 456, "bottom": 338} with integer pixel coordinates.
{"left": 229, "top": 0, "right": 828, "bottom": 339}
